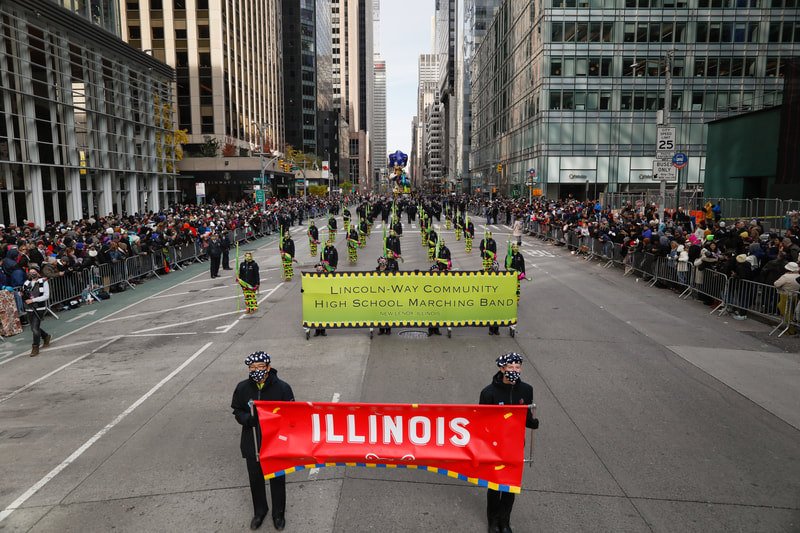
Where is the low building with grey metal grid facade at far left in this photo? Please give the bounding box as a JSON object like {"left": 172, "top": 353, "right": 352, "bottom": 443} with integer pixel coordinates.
{"left": 0, "top": 0, "right": 176, "bottom": 227}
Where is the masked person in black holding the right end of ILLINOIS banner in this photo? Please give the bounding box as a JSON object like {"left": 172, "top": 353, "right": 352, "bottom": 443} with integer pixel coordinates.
{"left": 479, "top": 353, "right": 539, "bottom": 533}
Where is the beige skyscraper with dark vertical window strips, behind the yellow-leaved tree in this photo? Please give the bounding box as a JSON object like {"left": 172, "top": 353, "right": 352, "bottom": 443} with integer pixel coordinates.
{"left": 121, "top": 0, "right": 289, "bottom": 199}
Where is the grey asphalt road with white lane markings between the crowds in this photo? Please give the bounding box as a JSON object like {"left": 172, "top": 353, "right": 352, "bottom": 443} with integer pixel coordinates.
{"left": 0, "top": 214, "right": 800, "bottom": 532}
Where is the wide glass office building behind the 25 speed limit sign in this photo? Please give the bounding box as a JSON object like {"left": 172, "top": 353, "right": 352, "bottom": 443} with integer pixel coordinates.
{"left": 471, "top": 0, "right": 800, "bottom": 198}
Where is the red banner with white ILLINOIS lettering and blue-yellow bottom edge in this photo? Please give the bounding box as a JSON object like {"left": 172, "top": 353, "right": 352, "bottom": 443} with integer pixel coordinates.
{"left": 255, "top": 402, "right": 528, "bottom": 493}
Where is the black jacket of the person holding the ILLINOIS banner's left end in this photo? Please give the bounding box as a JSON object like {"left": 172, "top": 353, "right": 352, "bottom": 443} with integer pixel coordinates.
{"left": 231, "top": 368, "right": 294, "bottom": 459}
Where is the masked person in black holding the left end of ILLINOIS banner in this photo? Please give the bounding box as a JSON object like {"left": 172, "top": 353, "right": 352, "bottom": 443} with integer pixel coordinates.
{"left": 231, "top": 351, "right": 294, "bottom": 531}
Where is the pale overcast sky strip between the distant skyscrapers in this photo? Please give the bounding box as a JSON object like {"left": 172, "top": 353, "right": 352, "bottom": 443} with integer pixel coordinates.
{"left": 381, "top": 0, "right": 435, "bottom": 164}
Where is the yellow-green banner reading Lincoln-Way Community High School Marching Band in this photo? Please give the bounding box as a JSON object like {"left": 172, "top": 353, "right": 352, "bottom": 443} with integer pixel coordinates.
{"left": 302, "top": 271, "right": 517, "bottom": 328}
